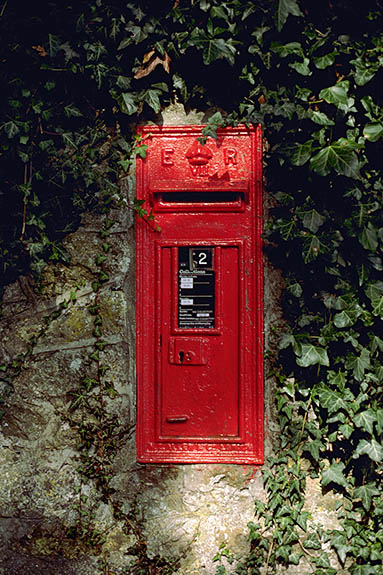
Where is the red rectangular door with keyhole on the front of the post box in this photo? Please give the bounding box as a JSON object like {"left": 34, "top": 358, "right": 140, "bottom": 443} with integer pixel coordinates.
{"left": 158, "top": 246, "right": 240, "bottom": 440}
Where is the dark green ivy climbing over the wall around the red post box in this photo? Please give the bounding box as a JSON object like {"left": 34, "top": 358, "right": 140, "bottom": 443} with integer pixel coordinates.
{"left": 0, "top": 0, "right": 383, "bottom": 575}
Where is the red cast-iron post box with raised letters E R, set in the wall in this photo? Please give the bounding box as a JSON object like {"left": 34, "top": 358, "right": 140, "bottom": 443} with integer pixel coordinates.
{"left": 137, "top": 126, "right": 263, "bottom": 463}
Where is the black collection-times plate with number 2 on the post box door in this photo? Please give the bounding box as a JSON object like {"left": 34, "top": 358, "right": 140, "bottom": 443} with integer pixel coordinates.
{"left": 178, "top": 246, "right": 215, "bottom": 329}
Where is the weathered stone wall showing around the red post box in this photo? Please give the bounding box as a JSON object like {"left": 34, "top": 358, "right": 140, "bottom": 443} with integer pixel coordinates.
{"left": 0, "top": 106, "right": 342, "bottom": 575}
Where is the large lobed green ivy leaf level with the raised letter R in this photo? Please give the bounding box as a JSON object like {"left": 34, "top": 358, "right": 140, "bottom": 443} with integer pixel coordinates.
{"left": 310, "top": 138, "right": 360, "bottom": 179}
